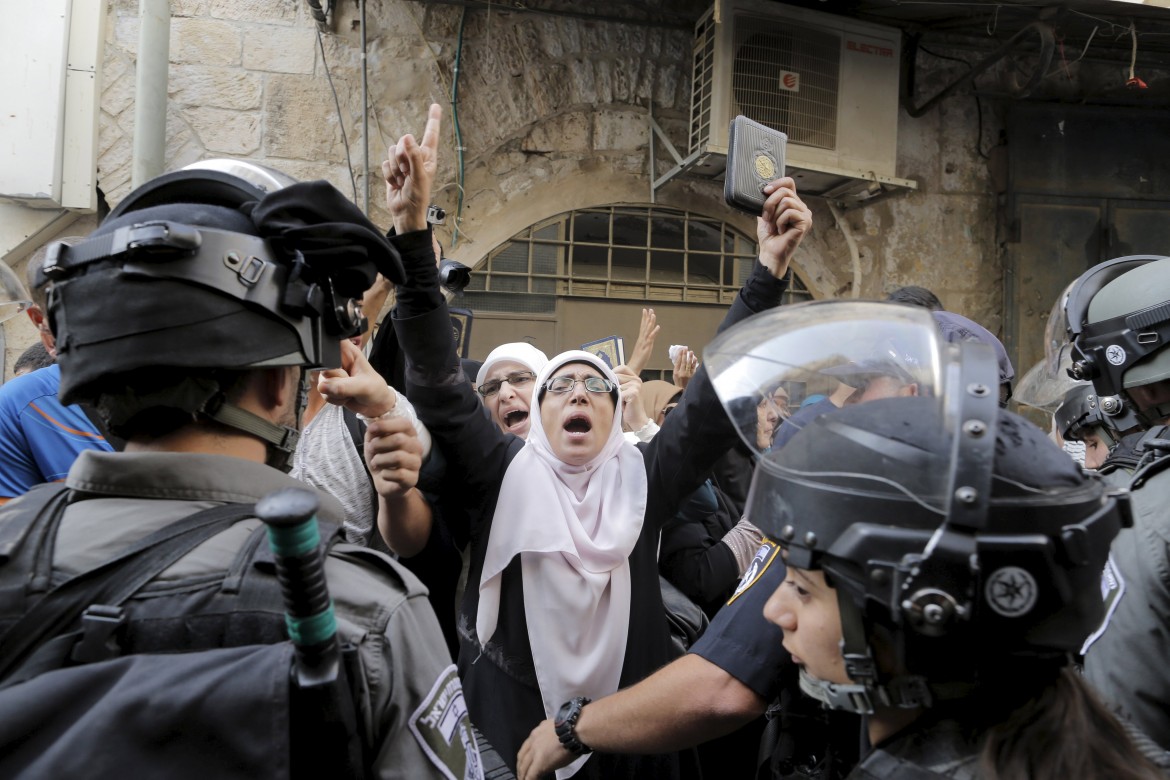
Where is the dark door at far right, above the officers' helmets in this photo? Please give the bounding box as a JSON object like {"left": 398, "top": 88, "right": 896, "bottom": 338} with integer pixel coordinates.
{"left": 1004, "top": 103, "right": 1170, "bottom": 383}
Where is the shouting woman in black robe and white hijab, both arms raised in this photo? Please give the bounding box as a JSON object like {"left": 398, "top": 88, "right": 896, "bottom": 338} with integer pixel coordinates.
{"left": 376, "top": 100, "right": 811, "bottom": 780}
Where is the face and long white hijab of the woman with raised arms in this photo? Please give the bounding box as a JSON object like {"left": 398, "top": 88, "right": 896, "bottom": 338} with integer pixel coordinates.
{"left": 475, "top": 351, "right": 645, "bottom": 776}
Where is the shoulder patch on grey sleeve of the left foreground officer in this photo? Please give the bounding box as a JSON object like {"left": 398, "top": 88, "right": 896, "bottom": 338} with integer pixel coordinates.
{"left": 411, "top": 664, "right": 483, "bottom": 780}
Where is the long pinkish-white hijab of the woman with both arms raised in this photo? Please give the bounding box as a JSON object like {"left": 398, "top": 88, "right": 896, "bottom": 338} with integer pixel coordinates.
{"left": 475, "top": 351, "right": 646, "bottom": 778}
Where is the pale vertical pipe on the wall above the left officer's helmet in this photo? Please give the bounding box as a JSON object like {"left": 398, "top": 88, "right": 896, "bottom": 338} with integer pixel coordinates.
{"left": 131, "top": 0, "right": 171, "bottom": 187}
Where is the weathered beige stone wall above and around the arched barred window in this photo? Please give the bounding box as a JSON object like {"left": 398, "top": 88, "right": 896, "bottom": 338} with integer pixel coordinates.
{"left": 8, "top": 0, "right": 1003, "bottom": 374}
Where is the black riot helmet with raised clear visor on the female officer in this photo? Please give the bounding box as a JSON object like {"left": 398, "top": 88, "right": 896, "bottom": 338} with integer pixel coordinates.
{"left": 704, "top": 302, "right": 1128, "bottom": 712}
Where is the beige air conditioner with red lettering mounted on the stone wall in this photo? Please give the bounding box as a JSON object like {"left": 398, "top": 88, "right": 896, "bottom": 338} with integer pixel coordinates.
{"left": 690, "top": 0, "right": 917, "bottom": 200}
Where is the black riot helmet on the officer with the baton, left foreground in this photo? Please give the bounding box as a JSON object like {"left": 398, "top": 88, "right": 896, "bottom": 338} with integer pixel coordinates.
{"left": 42, "top": 160, "right": 404, "bottom": 465}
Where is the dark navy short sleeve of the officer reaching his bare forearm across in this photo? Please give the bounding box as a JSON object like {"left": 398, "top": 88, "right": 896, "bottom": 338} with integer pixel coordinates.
{"left": 690, "top": 544, "right": 792, "bottom": 702}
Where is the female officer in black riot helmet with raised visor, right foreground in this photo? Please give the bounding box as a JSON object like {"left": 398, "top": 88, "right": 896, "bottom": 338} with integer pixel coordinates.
{"left": 706, "top": 304, "right": 1158, "bottom": 779}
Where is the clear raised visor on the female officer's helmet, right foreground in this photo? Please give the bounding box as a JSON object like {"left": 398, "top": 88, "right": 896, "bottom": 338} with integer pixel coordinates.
{"left": 704, "top": 302, "right": 998, "bottom": 565}
